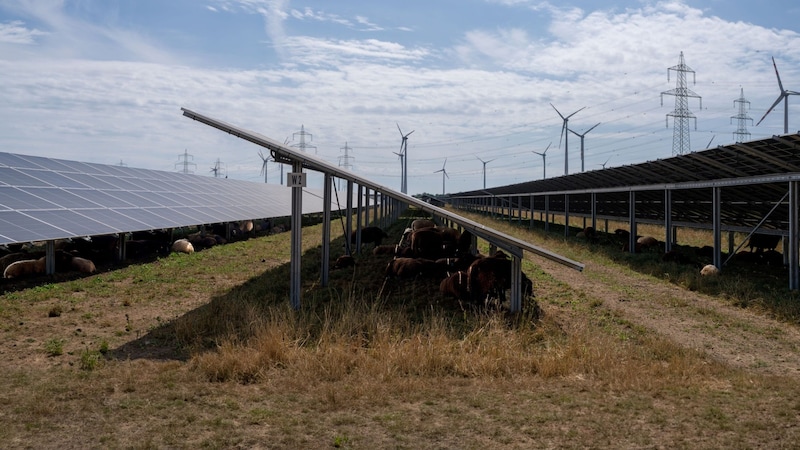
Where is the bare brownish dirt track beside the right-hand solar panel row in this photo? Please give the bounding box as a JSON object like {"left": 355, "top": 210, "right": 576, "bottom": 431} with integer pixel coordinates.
{"left": 531, "top": 256, "right": 800, "bottom": 375}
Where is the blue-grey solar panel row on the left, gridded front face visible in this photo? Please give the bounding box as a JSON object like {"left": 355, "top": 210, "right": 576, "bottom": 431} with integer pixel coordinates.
{"left": 0, "top": 153, "right": 340, "bottom": 244}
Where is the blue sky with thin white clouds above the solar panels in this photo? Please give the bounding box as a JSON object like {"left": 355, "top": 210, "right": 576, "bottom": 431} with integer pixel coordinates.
{"left": 0, "top": 0, "right": 800, "bottom": 194}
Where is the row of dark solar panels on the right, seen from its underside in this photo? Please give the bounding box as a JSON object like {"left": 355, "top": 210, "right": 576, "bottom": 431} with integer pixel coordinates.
{"left": 453, "top": 134, "right": 800, "bottom": 230}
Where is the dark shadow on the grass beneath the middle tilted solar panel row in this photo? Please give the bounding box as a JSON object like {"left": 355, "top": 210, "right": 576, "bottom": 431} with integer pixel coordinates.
{"left": 108, "top": 213, "right": 538, "bottom": 361}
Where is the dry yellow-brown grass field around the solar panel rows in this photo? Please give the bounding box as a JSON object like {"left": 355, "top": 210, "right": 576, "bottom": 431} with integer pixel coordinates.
{"left": 0, "top": 209, "right": 800, "bottom": 449}
